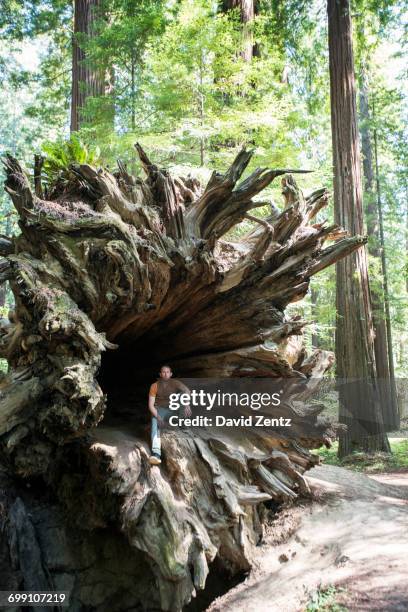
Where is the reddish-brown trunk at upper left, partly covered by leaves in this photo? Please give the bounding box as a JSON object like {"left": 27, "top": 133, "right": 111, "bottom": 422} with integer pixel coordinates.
{"left": 71, "top": 0, "right": 105, "bottom": 132}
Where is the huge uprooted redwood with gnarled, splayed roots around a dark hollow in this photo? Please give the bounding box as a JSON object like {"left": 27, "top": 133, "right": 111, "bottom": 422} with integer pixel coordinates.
{"left": 0, "top": 145, "right": 364, "bottom": 610}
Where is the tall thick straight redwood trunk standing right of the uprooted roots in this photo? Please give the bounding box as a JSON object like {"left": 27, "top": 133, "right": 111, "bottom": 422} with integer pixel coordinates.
{"left": 327, "top": 0, "right": 390, "bottom": 457}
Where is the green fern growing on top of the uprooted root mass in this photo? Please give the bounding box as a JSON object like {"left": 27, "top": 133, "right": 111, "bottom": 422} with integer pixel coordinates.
{"left": 42, "top": 134, "right": 100, "bottom": 184}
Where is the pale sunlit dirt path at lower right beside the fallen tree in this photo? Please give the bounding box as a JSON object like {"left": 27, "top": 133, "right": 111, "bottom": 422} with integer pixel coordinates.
{"left": 208, "top": 466, "right": 408, "bottom": 612}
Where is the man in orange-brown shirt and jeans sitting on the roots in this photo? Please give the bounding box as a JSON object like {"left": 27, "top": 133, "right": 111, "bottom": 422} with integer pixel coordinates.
{"left": 149, "top": 365, "right": 191, "bottom": 465}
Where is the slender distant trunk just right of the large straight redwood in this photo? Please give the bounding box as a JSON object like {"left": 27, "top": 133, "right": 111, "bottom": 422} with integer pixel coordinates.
{"left": 360, "top": 69, "right": 399, "bottom": 431}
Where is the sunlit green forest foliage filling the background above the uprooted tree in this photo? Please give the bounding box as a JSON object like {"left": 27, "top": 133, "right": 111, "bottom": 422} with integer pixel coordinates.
{"left": 0, "top": 0, "right": 408, "bottom": 376}
